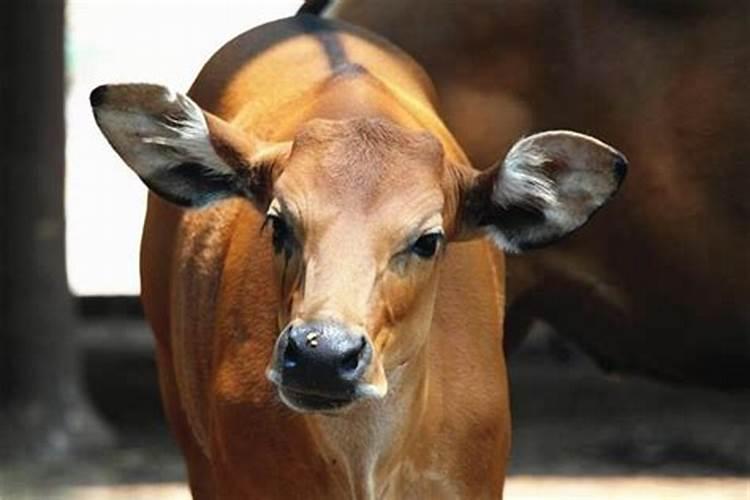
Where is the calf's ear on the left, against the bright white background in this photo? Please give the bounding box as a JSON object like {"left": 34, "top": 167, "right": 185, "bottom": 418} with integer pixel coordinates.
{"left": 90, "top": 84, "right": 289, "bottom": 207}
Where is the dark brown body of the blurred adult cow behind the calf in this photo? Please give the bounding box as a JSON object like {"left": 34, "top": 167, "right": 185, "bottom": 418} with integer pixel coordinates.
{"left": 326, "top": 0, "right": 750, "bottom": 388}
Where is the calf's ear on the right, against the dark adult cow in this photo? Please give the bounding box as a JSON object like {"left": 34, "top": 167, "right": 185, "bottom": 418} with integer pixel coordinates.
{"left": 461, "top": 130, "right": 627, "bottom": 252}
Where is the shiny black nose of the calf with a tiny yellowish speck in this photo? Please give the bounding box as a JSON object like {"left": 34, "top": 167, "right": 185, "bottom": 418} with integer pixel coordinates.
{"left": 279, "top": 322, "right": 372, "bottom": 399}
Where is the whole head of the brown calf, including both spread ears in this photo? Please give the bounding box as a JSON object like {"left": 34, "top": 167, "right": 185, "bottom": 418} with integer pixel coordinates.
{"left": 91, "top": 84, "right": 626, "bottom": 411}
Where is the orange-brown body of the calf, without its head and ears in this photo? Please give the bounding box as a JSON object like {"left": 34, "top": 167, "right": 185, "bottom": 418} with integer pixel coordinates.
{"left": 141, "top": 14, "right": 510, "bottom": 499}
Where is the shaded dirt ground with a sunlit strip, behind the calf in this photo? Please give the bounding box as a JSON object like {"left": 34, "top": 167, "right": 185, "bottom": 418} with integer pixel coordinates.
{"left": 0, "top": 322, "right": 750, "bottom": 500}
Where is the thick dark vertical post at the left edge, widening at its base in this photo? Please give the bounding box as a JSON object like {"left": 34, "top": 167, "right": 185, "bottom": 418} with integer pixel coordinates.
{"left": 0, "top": 0, "right": 111, "bottom": 457}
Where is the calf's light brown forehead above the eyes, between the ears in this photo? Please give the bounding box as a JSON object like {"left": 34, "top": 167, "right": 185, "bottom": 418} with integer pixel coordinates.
{"left": 276, "top": 118, "right": 450, "bottom": 216}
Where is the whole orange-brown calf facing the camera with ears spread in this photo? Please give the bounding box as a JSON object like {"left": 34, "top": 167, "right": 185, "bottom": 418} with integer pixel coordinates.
{"left": 91, "top": 15, "right": 626, "bottom": 499}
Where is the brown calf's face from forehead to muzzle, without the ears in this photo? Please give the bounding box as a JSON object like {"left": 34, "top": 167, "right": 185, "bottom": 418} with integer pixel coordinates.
{"left": 267, "top": 119, "right": 447, "bottom": 410}
